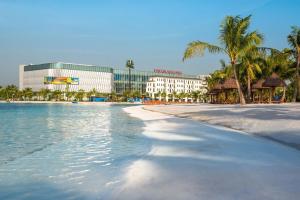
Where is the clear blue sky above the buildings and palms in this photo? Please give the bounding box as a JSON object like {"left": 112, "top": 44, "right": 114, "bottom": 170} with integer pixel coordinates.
{"left": 0, "top": 0, "right": 300, "bottom": 85}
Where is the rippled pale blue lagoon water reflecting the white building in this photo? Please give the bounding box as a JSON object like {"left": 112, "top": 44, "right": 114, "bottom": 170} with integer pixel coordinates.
{"left": 0, "top": 104, "right": 150, "bottom": 199}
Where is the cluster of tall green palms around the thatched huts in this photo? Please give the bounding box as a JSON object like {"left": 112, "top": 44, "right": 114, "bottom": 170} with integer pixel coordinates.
{"left": 183, "top": 15, "right": 300, "bottom": 104}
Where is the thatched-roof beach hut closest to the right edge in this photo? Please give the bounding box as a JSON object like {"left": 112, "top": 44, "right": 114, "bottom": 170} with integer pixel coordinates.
{"left": 262, "top": 73, "right": 286, "bottom": 103}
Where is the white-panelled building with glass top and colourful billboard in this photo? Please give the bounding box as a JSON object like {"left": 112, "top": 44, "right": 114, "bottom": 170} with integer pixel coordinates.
{"left": 19, "top": 62, "right": 113, "bottom": 93}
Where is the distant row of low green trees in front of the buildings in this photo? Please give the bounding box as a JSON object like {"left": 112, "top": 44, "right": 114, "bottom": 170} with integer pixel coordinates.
{"left": 0, "top": 85, "right": 207, "bottom": 102}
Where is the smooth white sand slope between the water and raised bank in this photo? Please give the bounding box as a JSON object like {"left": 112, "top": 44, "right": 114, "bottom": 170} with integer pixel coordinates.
{"left": 113, "top": 106, "right": 300, "bottom": 200}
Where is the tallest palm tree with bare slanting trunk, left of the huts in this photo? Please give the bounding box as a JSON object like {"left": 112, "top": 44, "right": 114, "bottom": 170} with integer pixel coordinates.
{"left": 183, "top": 15, "right": 263, "bottom": 105}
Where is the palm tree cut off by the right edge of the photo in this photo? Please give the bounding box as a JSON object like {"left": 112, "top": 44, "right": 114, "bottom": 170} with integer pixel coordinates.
{"left": 287, "top": 26, "right": 300, "bottom": 102}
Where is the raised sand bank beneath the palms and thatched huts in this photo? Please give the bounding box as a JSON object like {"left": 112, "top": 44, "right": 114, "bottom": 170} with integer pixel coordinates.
{"left": 145, "top": 104, "right": 300, "bottom": 149}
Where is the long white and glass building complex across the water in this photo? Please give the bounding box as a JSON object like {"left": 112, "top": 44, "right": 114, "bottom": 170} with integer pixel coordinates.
{"left": 19, "top": 62, "right": 205, "bottom": 95}
